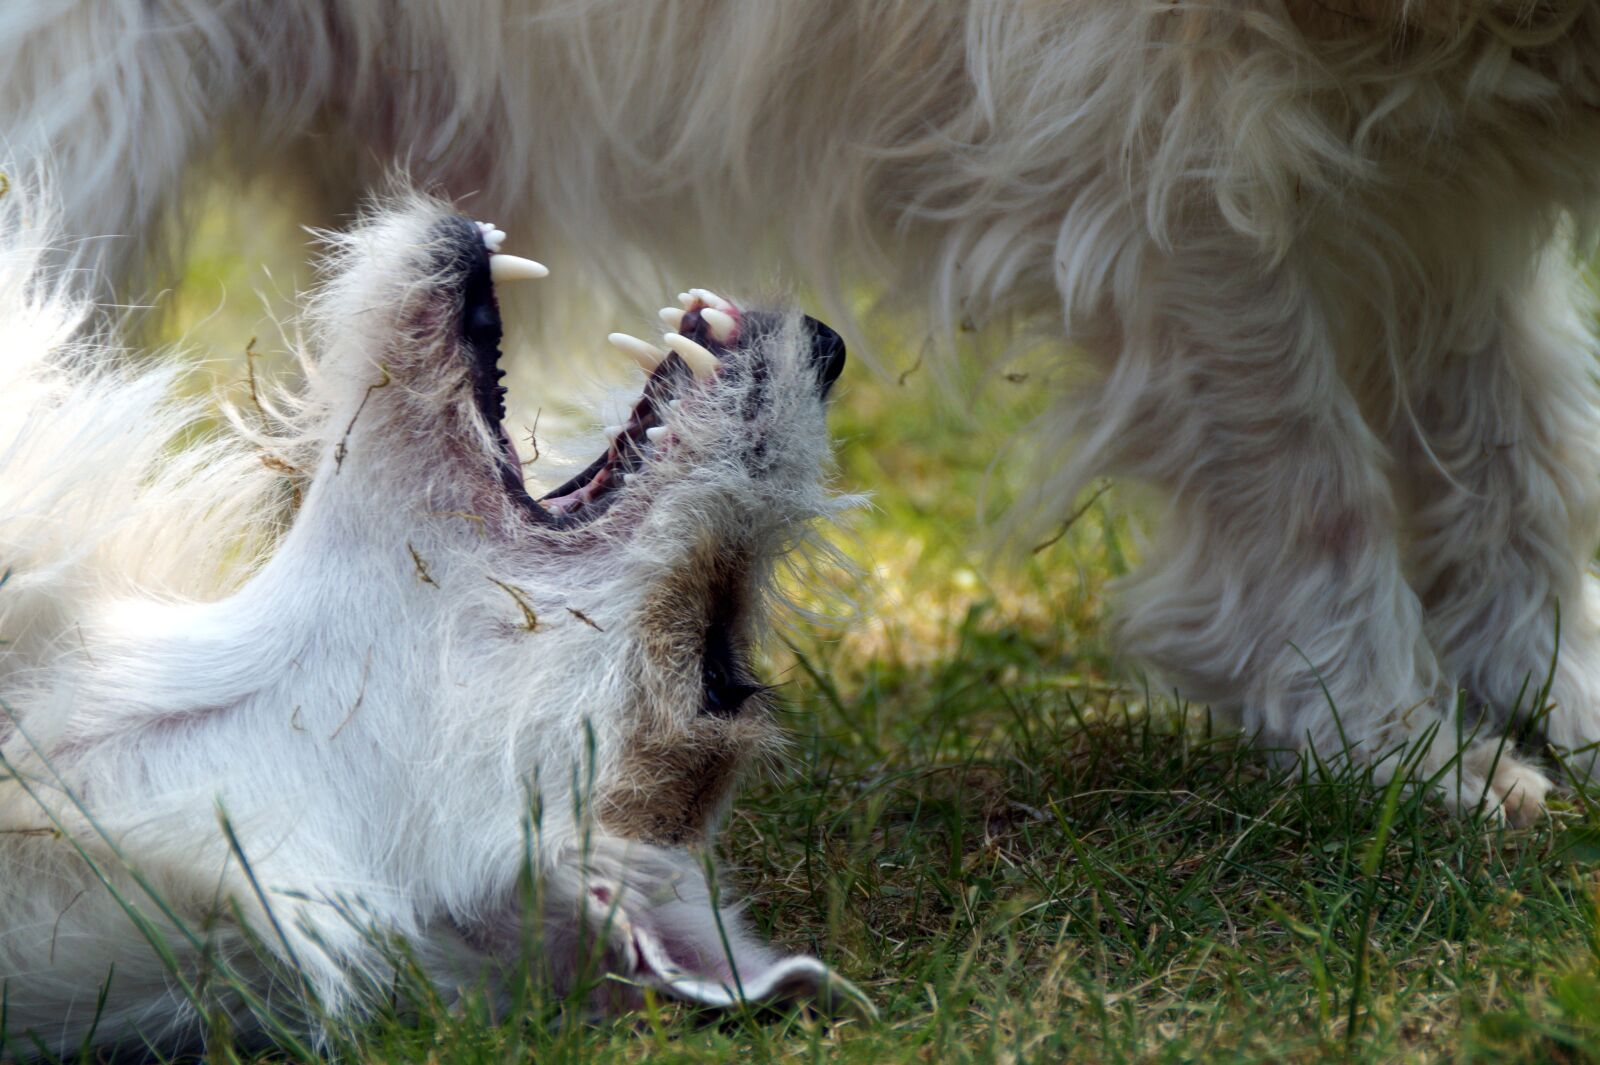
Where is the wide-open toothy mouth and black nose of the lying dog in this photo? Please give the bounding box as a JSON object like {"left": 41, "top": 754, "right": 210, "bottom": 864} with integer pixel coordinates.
{"left": 451, "top": 219, "right": 845, "bottom": 526}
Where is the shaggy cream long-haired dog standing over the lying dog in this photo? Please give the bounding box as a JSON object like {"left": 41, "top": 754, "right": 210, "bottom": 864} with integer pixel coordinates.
{"left": 0, "top": 0, "right": 1600, "bottom": 817}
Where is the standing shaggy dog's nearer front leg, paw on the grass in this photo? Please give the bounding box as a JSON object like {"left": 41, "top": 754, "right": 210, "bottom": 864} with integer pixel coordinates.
{"left": 1101, "top": 238, "right": 1547, "bottom": 819}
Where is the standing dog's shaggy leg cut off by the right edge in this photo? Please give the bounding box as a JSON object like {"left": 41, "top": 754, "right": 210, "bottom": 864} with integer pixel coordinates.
{"left": 1398, "top": 254, "right": 1600, "bottom": 772}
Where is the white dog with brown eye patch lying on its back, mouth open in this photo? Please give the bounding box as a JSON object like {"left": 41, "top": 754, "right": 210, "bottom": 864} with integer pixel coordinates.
{"left": 0, "top": 189, "right": 854, "bottom": 1057}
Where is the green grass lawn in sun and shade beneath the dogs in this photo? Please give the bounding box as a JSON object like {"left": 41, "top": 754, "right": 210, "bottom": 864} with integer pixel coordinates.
{"left": 18, "top": 191, "right": 1600, "bottom": 1063}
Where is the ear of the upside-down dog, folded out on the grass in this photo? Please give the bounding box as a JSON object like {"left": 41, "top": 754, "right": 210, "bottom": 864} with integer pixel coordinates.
{"left": 547, "top": 844, "right": 877, "bottom": 1017}
